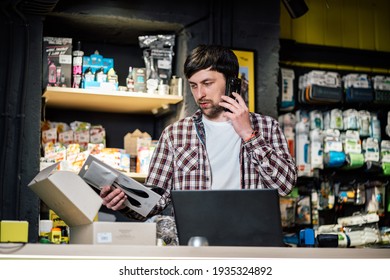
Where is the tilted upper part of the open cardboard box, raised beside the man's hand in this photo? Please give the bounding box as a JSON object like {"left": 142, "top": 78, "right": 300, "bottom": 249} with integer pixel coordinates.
{"left": 28, "top": 163, "right": 102, "bottom": 227}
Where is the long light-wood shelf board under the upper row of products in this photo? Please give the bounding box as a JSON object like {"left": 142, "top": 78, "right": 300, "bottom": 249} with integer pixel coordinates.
{"left": 43, "top": 87, "right": 183, "bottom": 114}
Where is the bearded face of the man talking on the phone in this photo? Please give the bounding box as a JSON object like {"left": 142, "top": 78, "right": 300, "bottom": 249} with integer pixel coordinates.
{"left": 188, "top": 69, "right": 226, "bottom": 119}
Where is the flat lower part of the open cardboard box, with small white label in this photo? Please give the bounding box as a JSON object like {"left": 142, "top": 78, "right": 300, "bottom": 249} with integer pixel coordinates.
{"left": 70, "top": 222, "right": 156, "bottom": 245}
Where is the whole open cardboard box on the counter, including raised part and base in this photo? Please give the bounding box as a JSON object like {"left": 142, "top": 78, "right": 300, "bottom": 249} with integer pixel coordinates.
{"left": 28, "top": 163, "right": 156, "bottom": 245}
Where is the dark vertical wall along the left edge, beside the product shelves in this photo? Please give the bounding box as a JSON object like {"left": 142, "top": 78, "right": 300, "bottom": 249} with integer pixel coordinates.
{"left": 0, "top": 9, "right": 42, "bottom": 240}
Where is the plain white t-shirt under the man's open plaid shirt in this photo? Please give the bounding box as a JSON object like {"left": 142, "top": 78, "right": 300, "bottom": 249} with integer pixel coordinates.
{"left": 203, "top": 117, "right": 241, "bottom": 190}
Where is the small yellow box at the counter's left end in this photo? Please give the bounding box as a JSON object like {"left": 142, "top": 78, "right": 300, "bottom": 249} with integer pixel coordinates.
{"left": 0, "top": 220, "right": 28, "bottom": 243}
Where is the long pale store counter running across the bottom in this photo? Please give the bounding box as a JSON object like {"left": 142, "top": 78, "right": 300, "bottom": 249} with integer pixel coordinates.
{"left": 0, "top": 243, "right": 390, "bottom": 259}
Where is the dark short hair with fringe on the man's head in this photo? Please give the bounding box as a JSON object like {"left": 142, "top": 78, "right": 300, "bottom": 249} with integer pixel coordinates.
{"left": 184, "top": 45, "right": 239, "bottom": 79}
